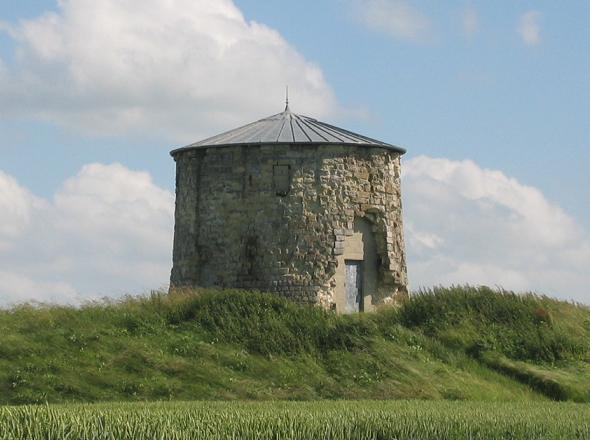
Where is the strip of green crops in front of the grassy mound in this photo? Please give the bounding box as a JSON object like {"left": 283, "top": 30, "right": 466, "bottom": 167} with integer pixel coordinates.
{"left": 0, "top": 400, "right": 590, "bottom": 440}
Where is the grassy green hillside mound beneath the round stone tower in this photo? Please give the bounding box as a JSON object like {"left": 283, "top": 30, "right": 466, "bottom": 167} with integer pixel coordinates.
{"left": 0, "top": 287, "right": 590, "bottom": 404}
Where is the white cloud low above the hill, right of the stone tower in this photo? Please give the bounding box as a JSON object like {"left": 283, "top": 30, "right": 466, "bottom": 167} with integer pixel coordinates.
{"left": 403, "top": 156, "right": 590, "bottom": 303}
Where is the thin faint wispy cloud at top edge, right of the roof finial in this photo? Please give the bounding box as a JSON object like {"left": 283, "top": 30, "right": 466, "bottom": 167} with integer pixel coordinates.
{"left": 353, "top": 0, "right": 432, "bottom": 42}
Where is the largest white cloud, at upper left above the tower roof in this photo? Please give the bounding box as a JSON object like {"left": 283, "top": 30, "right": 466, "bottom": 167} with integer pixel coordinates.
{"left": 0, "top": 0, "right": 338, "bottom": 143}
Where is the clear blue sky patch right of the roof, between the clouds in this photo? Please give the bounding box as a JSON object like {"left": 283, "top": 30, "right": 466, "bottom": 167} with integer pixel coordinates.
{"left": 237, "top": 0, "right": 590, "bottom": 226}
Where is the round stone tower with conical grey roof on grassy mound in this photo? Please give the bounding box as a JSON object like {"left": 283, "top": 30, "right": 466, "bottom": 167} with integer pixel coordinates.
{"left": 170, "top": 106, "right": 407, "bottom": 313}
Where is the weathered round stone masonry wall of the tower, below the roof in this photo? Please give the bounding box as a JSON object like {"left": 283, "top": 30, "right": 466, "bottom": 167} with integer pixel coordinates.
{"left": 171, "top": 145, "right": 407, "bottom": 307}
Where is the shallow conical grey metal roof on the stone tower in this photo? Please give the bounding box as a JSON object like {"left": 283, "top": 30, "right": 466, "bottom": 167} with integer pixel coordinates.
{"left": 170, "top": 105, "right": 406, "bottom": 155}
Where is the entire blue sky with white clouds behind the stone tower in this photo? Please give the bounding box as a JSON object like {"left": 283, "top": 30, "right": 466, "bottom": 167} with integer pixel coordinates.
{"left": 0, "top": 0, "right": 590, "bottom": 305}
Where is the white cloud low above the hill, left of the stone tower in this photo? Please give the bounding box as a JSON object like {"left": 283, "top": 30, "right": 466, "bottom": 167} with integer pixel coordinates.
{"left": 0, "top": 164, "right": 174, "bottom": 305}
